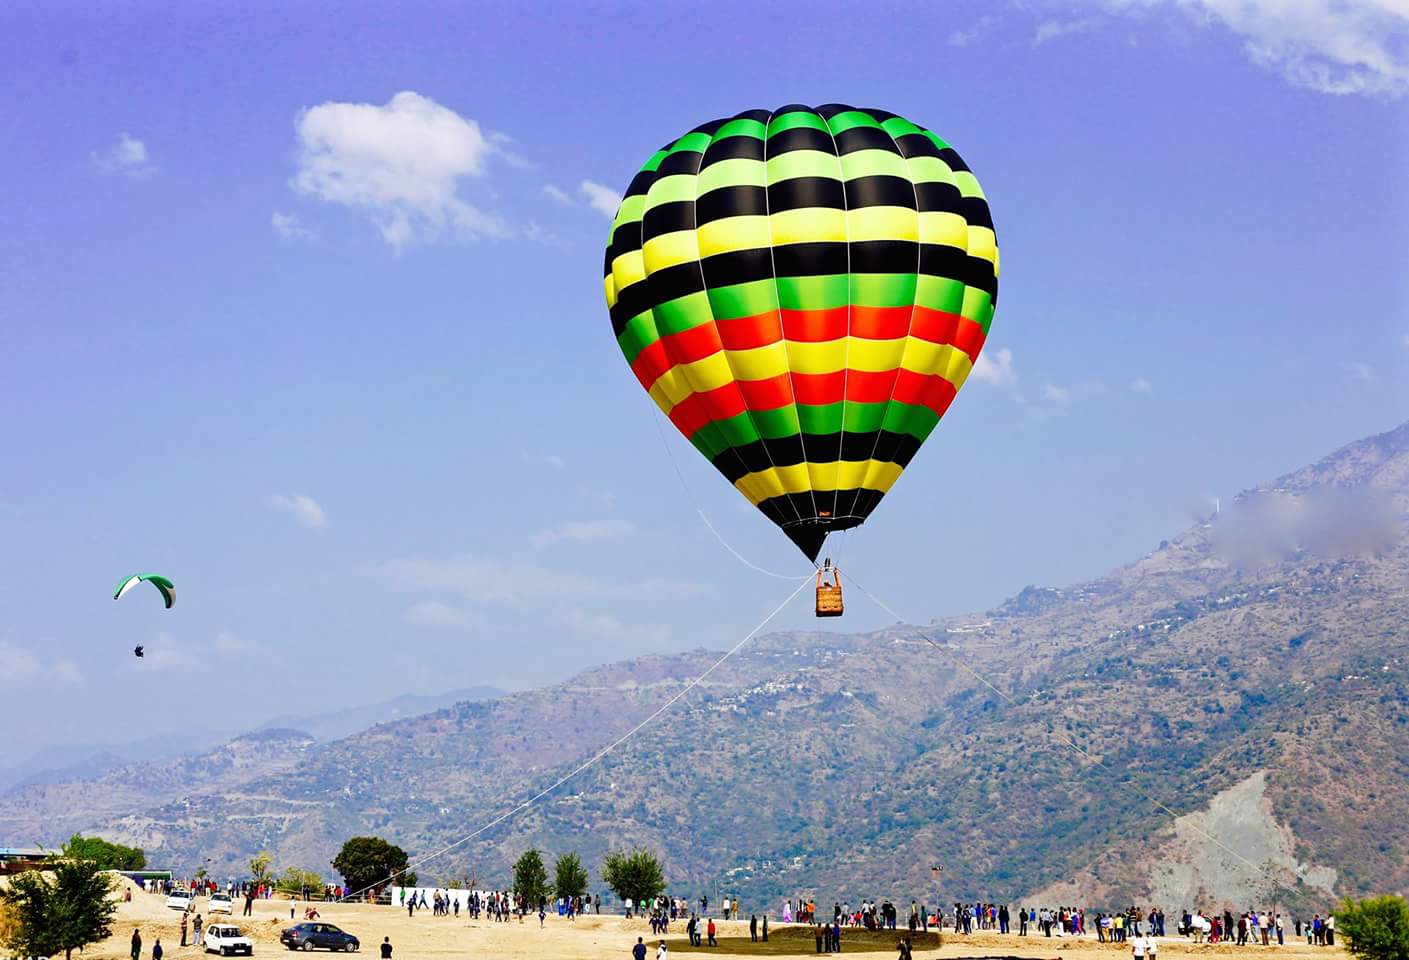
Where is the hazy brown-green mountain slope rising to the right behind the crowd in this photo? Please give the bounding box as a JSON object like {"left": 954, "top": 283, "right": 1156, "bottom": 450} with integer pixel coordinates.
{"left": 13, "top": 424, "right": 1409, "bottom": 909}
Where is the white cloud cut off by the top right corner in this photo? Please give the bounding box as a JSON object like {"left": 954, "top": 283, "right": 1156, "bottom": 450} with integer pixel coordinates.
{"left": 1107, "top": 0, "right": 1409, "bottom": 97}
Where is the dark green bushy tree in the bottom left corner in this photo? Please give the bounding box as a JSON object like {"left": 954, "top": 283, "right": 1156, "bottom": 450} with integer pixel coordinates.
{"left": 0, "top": 860, "right": 117, "bottom": 957}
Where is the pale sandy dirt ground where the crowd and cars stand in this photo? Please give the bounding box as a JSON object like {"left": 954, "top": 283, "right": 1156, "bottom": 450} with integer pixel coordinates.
{"left": 99, "top": 892, "right": 1347, "bottom": 960}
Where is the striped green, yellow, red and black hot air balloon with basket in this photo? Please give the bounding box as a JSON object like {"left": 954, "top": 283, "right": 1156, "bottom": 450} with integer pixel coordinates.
{"left": 604, "top": 104, "right": 998, "bottom": 583}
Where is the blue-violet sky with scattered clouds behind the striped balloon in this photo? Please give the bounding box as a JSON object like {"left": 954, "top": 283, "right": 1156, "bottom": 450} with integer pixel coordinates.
{"left": 0, "top": 0, "right": 1409, "bottom": 758}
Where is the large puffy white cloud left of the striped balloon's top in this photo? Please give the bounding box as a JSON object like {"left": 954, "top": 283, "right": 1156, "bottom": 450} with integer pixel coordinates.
{"left": 292, "top": 90, "right": 509, "bottom": 250}
